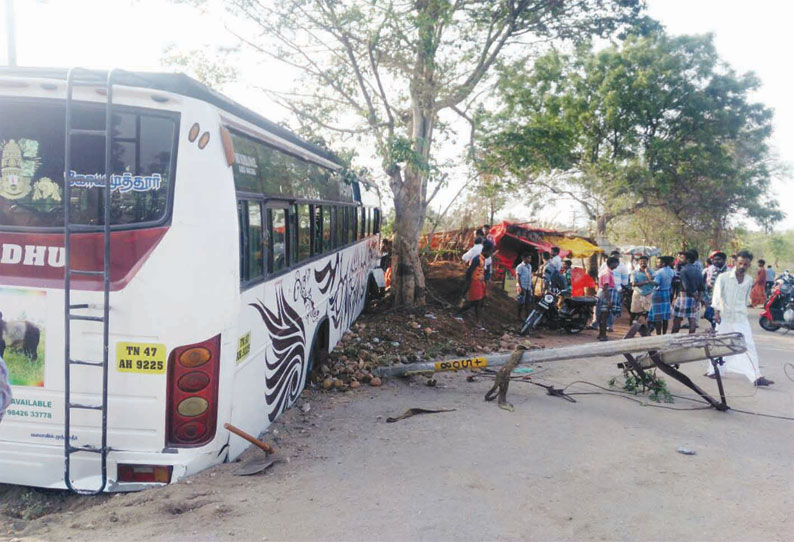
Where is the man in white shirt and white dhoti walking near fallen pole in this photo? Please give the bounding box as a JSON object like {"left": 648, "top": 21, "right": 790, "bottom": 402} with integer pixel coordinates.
{"left": 706, "top": 250, "right": 774, "bottom": 386}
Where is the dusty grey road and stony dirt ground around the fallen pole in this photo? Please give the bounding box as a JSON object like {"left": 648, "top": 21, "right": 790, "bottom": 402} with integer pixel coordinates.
{"left": 0, "top": 270, "right": 794, "bottom": 541}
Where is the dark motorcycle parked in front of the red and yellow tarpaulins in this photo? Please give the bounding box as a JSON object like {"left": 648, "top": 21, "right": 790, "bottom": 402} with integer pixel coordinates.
{"left": 521, "top": 288, "right": 598, "bottom": 335}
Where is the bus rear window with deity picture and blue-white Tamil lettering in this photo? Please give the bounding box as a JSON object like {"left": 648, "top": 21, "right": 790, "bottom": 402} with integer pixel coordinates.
{"left": 0, "top": 100, "right": 176, "bottom": 228}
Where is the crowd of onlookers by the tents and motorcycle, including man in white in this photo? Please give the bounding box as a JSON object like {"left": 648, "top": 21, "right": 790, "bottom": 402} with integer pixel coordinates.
{"left": 452, "top": 225, "right": 775, "bottom": 392}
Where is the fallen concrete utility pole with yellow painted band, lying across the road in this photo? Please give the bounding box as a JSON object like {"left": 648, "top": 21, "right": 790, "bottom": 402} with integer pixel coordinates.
{"left": 375, "top": 333, "right": 746, "bottom": 376}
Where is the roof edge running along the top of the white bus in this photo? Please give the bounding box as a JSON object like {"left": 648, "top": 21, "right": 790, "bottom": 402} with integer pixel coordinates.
{"left": 0, "top": 67, "right": 339, "bottom": 164}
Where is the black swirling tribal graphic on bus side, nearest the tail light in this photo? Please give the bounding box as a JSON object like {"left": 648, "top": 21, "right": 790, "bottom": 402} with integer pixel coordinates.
{"left": 250, "top": 287, "right": 306, "bottom": 422}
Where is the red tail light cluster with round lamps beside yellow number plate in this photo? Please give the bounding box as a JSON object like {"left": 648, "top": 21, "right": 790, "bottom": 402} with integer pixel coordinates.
{"left": 166, "top": 335, "right": 221, "bottom": 448}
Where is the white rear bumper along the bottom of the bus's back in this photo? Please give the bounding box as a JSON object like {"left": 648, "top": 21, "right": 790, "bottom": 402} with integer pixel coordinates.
{"left": 0, "top": 441, "right": 223, "bottom": 492}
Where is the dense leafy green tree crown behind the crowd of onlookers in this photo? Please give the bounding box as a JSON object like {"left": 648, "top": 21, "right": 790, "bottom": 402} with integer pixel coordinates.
{"left": 481, "top": 32, "right": 781, "bottom": 244}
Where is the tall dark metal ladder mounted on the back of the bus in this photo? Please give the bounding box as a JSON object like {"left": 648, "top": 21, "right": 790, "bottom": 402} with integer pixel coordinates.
{"left": 63, "top": 68, "right": 114, "bottom": 495}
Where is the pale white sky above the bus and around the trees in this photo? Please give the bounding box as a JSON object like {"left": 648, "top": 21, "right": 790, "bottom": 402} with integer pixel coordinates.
{"left": 0, "top": 0, "right": 794, "bottom": 229}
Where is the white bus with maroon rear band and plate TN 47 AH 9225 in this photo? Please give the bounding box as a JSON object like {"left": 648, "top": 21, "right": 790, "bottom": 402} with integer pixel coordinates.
{"left": 0, "top": 68, "right": 383, "bottom": 493}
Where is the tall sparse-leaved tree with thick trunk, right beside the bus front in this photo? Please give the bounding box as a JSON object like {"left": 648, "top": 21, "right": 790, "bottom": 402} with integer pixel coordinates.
{"left": 191, "top": 0, "right": 643, "bottom": 305}
